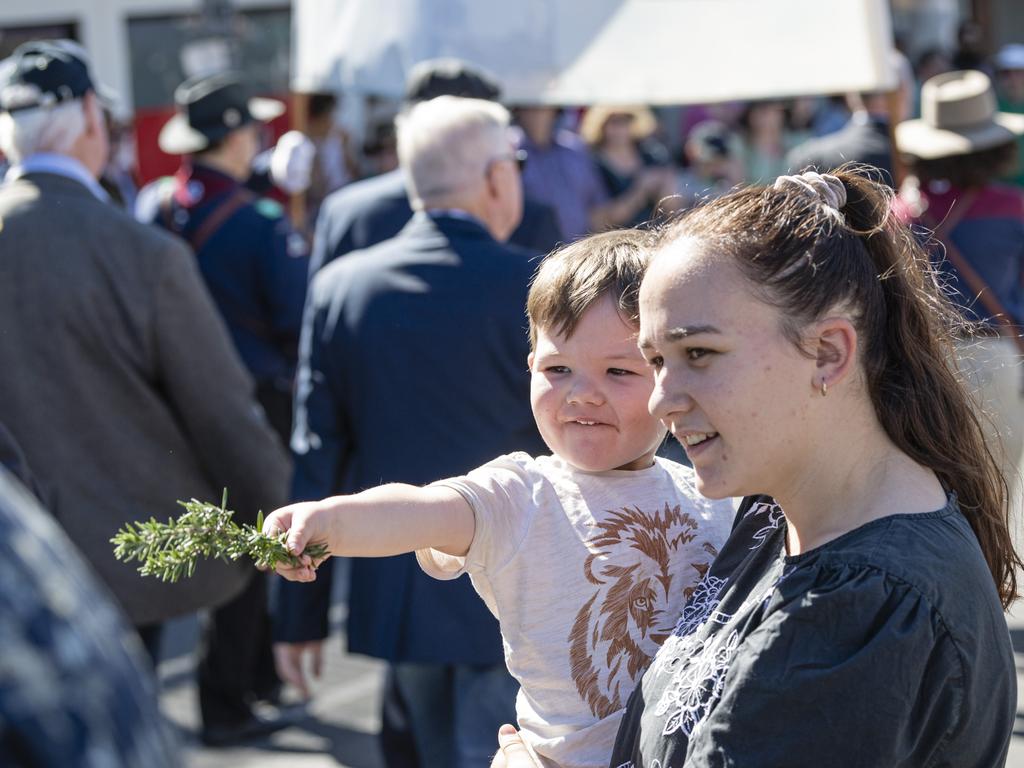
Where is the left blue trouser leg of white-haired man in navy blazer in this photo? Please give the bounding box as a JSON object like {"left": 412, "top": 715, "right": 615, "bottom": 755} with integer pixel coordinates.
{"left": 392, "top": 662, "right": 456, "bottom": 768}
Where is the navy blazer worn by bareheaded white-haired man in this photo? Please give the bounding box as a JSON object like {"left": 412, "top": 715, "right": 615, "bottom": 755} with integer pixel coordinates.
{"left": 274, "top": 213, "right": 545, "bottom": 664}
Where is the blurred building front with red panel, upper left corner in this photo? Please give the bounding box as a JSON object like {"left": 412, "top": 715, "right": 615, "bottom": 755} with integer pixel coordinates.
{"left": 0, "top": 0, "right": 292, "bottom": 182}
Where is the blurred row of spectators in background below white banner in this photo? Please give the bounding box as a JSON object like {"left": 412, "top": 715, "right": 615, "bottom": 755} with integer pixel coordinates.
{"left": 49, "top": 27, "right": 1024, "bottom": 242}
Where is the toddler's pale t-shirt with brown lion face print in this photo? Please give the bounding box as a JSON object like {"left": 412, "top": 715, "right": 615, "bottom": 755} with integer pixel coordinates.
{"left": 417, "top": 453, "right": 734, "bottom": 768}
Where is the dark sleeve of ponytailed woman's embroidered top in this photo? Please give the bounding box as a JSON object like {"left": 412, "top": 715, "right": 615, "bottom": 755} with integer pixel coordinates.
{"left": 686, "top": 566, "right": 962, "bottom": 768}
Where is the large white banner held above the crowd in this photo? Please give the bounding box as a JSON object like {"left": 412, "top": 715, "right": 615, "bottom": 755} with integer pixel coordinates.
{"left": 293, "top": 0, "right": 895, "bottom": 104}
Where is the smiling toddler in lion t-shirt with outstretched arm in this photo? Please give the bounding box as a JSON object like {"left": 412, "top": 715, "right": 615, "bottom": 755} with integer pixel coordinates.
{"left": 264, "top": 230, "right": 733, "bottom": 768}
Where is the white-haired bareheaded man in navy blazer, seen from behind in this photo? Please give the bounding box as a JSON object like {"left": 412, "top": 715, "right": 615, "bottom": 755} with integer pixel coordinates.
{"left": 275, "top": 96, "right": 544, "bottom": 767}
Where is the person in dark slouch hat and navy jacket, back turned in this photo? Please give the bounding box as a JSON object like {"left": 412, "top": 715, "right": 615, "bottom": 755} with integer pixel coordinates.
{"left": 136, "top": 73, "right": 308, "bottom": 740}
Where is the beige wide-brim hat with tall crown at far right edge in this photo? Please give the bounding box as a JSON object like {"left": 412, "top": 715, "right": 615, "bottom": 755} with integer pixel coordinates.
{"left": 896, "top": 70, "right": 1024, "bottom": 160}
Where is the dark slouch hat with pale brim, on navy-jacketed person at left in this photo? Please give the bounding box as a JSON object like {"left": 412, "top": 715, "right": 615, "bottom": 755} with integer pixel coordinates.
{"left": 157, "top": 73, "right": 285, "bottom": 155}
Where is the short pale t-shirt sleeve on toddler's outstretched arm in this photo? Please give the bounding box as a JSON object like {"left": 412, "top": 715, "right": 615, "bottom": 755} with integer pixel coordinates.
{"left": 416, "top": 454, "right": 541, "bottom": 579}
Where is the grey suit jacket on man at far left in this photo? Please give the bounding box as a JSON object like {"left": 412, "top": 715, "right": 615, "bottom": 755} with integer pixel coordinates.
{"left": 0, "top": 173, "right": 289, "bottom": 625}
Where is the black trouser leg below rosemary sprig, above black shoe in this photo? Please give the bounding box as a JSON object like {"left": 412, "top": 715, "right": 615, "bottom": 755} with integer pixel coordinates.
{"left": 198, "top": 573, "right": 273, "bottom": 727}
